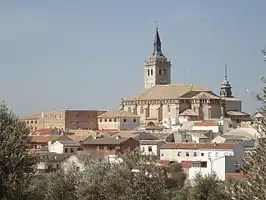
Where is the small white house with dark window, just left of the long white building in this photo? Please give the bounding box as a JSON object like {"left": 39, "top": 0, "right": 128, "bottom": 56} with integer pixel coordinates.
{"left": 140, "top": 140, "right": 165, "bottom": 156}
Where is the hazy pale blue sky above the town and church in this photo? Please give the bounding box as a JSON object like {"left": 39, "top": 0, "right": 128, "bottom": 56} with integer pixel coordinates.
{"left": 0, "top": 0, "right": 266, "bottom": 115}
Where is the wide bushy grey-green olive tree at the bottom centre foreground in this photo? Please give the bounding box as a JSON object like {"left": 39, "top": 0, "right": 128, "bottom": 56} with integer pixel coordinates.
{"left": 79, "top": 152, "right": 166, "bottom": 200}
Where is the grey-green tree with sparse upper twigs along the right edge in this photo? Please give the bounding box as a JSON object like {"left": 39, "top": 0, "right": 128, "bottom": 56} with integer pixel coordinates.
{"left": 229, "top": 57, "right": 266, "bottom": 200}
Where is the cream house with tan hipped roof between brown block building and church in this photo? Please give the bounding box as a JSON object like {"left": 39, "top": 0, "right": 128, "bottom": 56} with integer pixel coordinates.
{"left": 98, "top": 110, "right": 140, "bottom": 130}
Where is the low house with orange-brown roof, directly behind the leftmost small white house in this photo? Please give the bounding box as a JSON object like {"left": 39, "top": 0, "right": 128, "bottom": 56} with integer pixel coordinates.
{"left": 28, "top": 135, "right": 72, "bottom": 150}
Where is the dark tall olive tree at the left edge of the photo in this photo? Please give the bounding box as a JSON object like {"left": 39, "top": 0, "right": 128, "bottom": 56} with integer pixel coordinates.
{"left": 0, "top": 103, "right": 36, "bottom": 200}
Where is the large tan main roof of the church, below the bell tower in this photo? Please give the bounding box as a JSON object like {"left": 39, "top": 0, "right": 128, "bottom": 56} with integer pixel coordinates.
{"left": 130, "top": 84, "right": 207, "bottom": 100}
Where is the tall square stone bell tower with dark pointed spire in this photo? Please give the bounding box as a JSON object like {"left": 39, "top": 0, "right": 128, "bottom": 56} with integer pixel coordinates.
{"left": 144, "top": 24, "right": 171, "bottom": 89}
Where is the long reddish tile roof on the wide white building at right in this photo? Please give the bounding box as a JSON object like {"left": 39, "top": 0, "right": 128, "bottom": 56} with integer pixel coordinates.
{"left": 161, "top": 142, "right": 236, "bottom": 149}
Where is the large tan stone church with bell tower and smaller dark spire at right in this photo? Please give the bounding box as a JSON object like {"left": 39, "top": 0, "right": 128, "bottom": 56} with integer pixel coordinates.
{"left": 120, "top": 28, "right": 241, "bottom": 126}
